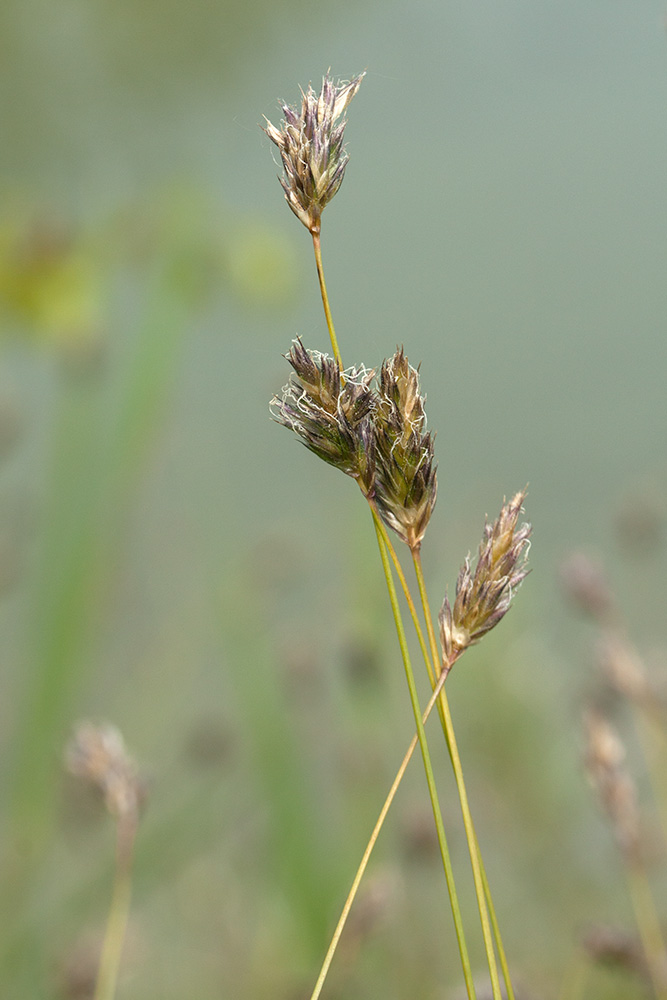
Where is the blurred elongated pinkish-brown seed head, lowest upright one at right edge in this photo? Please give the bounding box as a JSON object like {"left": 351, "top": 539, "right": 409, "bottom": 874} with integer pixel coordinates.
{"left": 584, "top": 709, "right": 640, "bottom": 858}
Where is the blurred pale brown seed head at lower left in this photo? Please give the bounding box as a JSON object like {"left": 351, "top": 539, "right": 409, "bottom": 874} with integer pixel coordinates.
{"left": 65, "top": 722, "right": 145, "bottom": 823}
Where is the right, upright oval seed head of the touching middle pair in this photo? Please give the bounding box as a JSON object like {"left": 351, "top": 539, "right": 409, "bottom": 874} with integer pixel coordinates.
{"left": 374, "top": 348, "right": 438, "bottom": 550}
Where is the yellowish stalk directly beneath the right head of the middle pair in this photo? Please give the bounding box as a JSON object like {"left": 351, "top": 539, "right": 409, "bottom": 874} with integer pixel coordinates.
{"left": 412, "top": 547, "right": 511, "bottom": 1000}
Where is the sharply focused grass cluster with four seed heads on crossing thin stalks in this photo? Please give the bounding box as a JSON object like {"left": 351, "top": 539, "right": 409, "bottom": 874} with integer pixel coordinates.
{"left": 266, "top": 75, "right": 530, "bottom": 1000}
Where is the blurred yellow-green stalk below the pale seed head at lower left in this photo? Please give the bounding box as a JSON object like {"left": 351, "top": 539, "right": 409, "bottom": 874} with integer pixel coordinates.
{"left": 93, "top": 818, "right": 136, "bottom": 1000}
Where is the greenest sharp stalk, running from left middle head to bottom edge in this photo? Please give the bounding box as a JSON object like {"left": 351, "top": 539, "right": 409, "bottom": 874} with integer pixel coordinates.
{"left": 373, "top": 511, "right": 475, "bottom": 1000}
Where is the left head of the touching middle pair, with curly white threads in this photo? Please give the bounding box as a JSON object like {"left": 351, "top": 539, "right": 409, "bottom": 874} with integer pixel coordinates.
{"left": 271, "top": 339, "right": 376, "bottom": 498}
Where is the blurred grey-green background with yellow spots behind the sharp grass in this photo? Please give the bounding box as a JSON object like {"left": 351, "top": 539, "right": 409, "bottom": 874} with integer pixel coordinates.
{"left": 0, "top": 0, "right": 667, "bottom": 1000}
